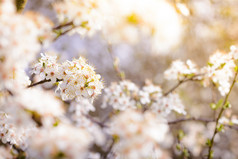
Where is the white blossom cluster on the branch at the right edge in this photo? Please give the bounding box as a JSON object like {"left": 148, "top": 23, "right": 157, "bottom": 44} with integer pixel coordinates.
{"left": 164, "top": 46, "right": 238, "bottom": 96}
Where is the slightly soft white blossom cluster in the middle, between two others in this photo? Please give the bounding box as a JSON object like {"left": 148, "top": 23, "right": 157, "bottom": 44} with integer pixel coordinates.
{"left": 102, "top": 80, "right": 186, "bottom": 116}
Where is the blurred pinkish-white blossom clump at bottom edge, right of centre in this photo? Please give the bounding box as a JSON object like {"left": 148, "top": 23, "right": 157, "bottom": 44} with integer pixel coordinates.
{"left": 110, "top": 109, "right": 168, "bottom": 159}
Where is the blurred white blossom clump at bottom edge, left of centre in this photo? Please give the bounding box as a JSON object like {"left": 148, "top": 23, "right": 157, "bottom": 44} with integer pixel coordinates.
{"left": 27, "top": 123, "right": 92, "bottom": 159}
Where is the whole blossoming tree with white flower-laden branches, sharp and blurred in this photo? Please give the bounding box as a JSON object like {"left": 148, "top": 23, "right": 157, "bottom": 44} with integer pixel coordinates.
{"left": 0, "top": 0, "right": 238, "bottom": 159}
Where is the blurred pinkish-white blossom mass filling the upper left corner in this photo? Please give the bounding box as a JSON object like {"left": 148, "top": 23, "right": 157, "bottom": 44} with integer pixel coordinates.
{"left": 0, "top": 0, "right": 52, "bottom": 91}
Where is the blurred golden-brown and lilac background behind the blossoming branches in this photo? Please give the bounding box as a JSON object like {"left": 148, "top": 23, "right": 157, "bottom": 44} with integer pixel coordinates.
{"left": 25, "top": 0, "right": 238, "bottom": 159}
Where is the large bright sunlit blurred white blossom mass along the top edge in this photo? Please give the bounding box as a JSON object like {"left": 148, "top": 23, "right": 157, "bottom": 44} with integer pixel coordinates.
{"left": 54, "top": 0, "right": 182, "bottom": 53}
